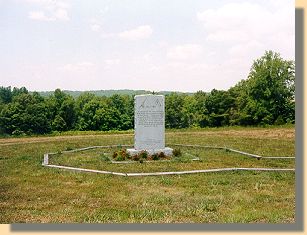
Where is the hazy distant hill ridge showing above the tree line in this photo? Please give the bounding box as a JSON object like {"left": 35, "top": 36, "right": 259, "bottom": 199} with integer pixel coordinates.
{"left": 38, "top": 89, "right": 193, "bottom": 98}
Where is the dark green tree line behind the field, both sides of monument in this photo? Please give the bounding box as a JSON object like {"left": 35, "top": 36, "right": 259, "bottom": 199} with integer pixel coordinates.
{"left": 0, "top": 51, "right": 295, "bottom": 135}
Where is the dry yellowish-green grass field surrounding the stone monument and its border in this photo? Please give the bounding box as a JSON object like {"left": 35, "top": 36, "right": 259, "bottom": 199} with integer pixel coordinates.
{"left": 0, "top": 126, "right": 295, "bottom": 223}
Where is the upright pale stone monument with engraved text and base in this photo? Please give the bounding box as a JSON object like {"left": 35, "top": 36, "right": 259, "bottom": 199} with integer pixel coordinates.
{"left": 127, "top": 95, "right": 173, "bottom": 156}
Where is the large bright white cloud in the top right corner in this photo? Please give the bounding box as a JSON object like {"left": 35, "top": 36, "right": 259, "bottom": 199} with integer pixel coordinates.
{"left": 197, "top": 0, "right": 294, "bottom": 42}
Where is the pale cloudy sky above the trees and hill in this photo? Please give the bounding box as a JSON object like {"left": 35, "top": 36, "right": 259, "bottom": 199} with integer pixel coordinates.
{"left": 0, "top": 0, "right": 295, "bottom": 92}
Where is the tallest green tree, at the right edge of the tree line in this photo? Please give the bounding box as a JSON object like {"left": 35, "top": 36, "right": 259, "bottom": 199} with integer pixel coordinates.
{"left": 239, "top": 51, "right": 295, "bottom": 125}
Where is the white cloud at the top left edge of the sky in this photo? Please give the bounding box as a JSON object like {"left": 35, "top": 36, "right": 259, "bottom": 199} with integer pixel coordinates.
{"left": 27, "top": 0, "right": 70, "bottom": 21}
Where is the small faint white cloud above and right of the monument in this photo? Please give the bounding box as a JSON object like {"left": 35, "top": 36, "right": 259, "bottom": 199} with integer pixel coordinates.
{"left": 166, "top": 44, "right": 203, "bottom": 60}
